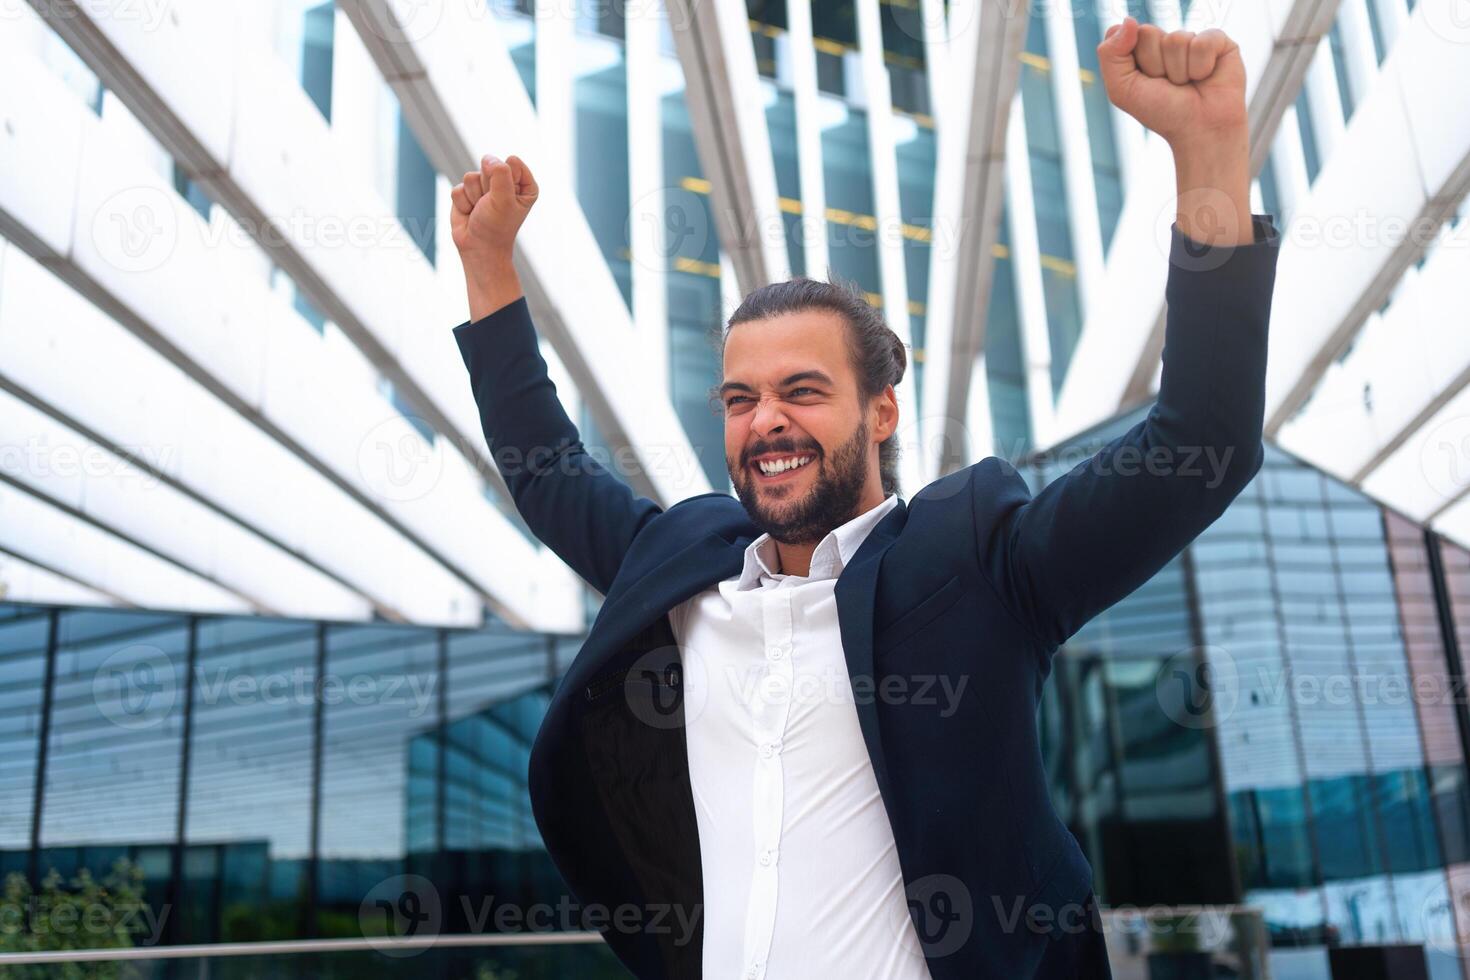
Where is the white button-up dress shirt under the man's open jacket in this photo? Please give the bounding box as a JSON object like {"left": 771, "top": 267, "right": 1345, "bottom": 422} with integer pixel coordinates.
{"left": 669, "top": 494, "right": 929, "bottom": 980}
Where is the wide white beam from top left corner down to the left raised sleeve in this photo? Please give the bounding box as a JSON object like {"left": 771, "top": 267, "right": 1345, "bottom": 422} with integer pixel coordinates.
{"left": 22, "top": 0, "right": 543, "bottom": 514}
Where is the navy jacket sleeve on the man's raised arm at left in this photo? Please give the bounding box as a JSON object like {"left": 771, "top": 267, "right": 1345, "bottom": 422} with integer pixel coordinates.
{"left": 454, "top": 297, "right": 662, "bottom": 595}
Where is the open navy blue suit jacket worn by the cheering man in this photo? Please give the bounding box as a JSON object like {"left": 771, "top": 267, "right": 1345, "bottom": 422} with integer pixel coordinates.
{"left": 454, "top": 215, "right": 1279, "bottom": 980}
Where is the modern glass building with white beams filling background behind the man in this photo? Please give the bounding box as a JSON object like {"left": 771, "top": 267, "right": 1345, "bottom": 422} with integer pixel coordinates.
{"left": 0, "top": 0, "right": 1470, "bottom": 980}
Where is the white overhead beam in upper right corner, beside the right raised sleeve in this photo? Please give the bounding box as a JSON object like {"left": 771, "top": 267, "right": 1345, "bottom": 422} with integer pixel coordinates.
{"left": 1266, "top": 0, "right": 1470, "bottom": 433}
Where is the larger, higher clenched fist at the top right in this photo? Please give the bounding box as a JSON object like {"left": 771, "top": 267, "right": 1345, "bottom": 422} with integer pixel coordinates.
{"left": 1097, "top": 18, "right": 1247, "bottom": 147}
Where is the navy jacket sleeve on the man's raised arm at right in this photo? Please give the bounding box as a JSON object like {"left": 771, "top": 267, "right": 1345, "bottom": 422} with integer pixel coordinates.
{"left": 970, "top": 215, "right": 1280, "bottom": 654}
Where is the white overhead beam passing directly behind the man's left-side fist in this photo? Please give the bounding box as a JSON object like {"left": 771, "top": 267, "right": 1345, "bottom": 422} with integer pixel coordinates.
{"left": 340, "top": 0, "right": 711, "bottom": 507}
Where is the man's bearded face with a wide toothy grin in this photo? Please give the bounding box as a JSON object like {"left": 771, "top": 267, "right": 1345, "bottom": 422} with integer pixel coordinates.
{"left": 720, "top": 310, "right": 878, "bottom": 544}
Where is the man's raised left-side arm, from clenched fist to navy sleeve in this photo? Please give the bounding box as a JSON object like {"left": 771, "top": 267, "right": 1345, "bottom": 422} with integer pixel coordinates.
{"left": 450, "top": 156, "right": 660, "bottom": 594}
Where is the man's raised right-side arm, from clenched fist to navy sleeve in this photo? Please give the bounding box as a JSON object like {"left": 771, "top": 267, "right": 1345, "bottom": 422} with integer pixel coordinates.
{"left": 972, "top": 18, "right": 1280, "bottom": 648}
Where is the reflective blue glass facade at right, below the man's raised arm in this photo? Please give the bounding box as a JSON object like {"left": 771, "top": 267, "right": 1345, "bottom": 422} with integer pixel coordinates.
{"left": 1028, "top": 410, "right": 1470, "bottom": 977}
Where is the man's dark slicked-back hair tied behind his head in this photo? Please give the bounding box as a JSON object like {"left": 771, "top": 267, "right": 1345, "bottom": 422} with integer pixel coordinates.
{"left": 711, "top": 276, "right": 908, "bottom": 495}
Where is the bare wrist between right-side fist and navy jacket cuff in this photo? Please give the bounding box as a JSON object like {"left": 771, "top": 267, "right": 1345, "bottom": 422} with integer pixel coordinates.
{"left": 1169, "top": 126, "right": 1254, "bottom": 245}
